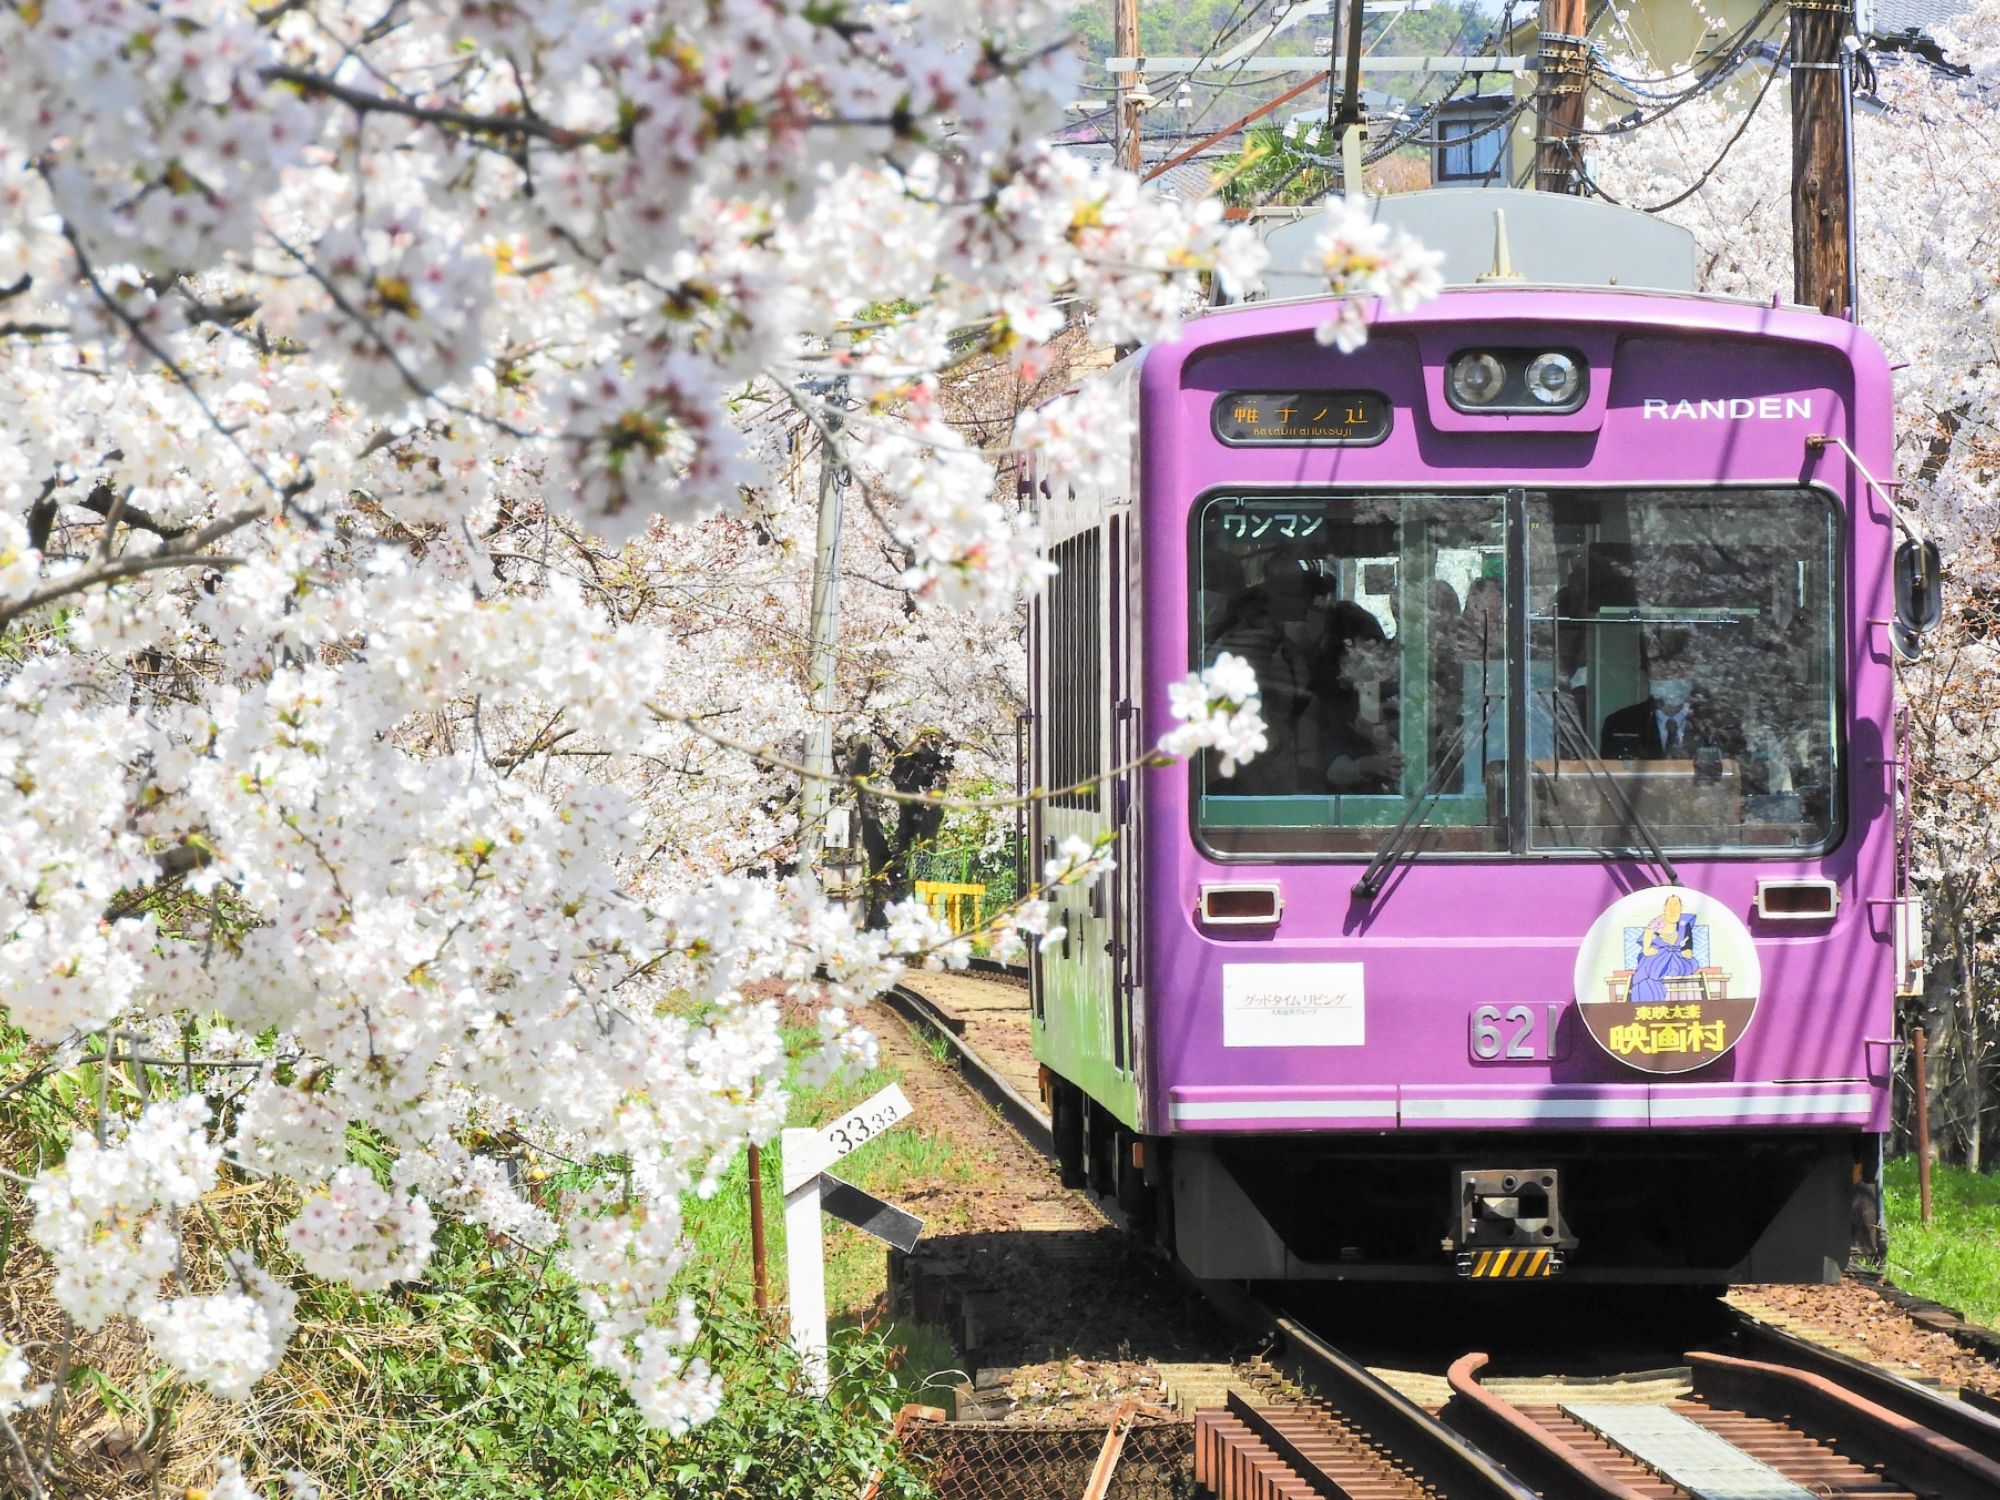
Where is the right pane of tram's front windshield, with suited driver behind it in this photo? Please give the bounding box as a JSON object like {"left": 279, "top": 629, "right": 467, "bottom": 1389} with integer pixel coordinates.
{"left": 1528, "top": 490, "right": 1840, "bottom": 850}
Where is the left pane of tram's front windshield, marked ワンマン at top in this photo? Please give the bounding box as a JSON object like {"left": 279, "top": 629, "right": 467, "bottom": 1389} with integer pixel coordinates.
{"left": 1194, "top": 496, "right": 1506, "bottom": 854}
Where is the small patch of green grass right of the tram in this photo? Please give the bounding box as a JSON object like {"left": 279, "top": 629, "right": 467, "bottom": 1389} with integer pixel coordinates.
{"left": 1882, "top": 1156, "right": 2000, "bottom": 1328}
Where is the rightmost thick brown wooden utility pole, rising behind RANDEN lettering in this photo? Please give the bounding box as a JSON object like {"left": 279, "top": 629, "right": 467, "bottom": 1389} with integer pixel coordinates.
{"left": 1792, "top": 0, "right": 1854, "bottom": 318}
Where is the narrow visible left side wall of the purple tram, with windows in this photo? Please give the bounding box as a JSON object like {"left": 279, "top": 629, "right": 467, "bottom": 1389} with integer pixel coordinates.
{"left": 1030, "top": 508, "right": 1138, "bottom": 1124}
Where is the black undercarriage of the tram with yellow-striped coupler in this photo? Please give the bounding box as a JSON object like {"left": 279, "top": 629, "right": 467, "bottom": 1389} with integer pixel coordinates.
{"left": 1050, "top": 1080, "right": 1856, "bottom": 1284}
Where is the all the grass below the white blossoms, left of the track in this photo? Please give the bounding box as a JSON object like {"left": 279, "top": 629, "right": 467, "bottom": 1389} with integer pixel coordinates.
{"left": 0, "top": 1028, "right": 952, "bottom": 1500}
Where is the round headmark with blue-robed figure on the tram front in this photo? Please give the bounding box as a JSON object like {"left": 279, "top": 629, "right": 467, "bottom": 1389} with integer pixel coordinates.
{"left": 1576, "top": 886, "right": 1764, "bottom": 1072}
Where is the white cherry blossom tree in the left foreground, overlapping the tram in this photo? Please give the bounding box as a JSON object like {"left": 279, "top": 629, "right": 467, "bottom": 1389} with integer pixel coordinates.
{"left": 0, "top": 0, "right": 1434, "bottom": 1494}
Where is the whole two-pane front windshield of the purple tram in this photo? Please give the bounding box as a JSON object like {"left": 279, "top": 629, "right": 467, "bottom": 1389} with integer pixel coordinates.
{"left": 1194, "top": 490, "right": 1840, "bottom": 856}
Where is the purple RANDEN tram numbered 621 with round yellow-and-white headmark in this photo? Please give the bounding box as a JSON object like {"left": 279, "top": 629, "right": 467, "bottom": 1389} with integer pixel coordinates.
{"left": 1026, "top": 212, "right": 1920, "bottom": 1284}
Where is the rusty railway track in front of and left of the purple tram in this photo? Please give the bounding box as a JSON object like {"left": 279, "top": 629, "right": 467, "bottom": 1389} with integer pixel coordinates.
{"left": 890, "top": 968, "right": 2000, "bottom": 1500}
